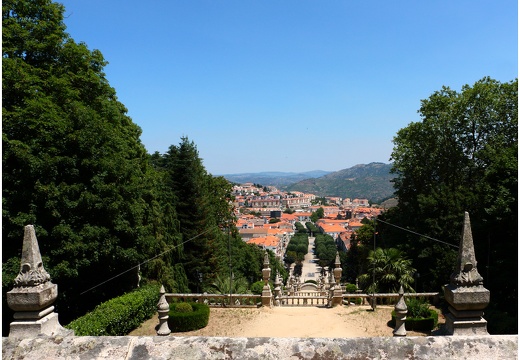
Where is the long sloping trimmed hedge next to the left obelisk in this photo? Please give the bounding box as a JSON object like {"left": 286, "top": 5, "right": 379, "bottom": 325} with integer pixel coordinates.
{"left": 65, "top": 284, "right": 160, "bottom": 336}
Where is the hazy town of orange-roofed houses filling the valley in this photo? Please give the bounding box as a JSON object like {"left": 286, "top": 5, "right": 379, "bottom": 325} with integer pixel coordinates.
{"left": 233, "top": 183, "right": 382, "bottom": 259}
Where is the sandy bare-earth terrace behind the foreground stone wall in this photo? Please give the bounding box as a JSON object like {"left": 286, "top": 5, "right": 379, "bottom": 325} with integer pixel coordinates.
{"left": 129, "top": 306, "right": 441, "bottom": 338}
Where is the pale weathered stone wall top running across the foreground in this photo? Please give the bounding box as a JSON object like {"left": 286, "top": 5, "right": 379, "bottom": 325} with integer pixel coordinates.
{"left": 2, "top": 335, "right": 518, "bottom": 360}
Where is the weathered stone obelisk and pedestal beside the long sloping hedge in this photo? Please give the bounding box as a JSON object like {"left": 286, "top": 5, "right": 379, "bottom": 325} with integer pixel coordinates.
{"left": 7, "top": 225, "right": 74, "bottom": 337}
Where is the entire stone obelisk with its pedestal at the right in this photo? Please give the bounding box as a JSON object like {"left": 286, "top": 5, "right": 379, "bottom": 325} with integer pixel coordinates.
{"left": 444, "top": 212, "right": 490, "bottom": 336}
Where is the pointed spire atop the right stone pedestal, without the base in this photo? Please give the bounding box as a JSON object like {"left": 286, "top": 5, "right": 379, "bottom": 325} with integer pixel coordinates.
{"left": 450, "top": 212, "right": 484, "bottom": 286}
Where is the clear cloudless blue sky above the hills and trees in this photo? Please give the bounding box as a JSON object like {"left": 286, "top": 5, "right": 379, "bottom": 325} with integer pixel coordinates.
{"left": 59, "top": 0, "right": 518, "bottom": 175}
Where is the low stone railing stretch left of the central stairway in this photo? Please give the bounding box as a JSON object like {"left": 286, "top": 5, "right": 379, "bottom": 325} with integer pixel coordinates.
{"left": 164, "top": 293, "right": 262, "bottom": 308}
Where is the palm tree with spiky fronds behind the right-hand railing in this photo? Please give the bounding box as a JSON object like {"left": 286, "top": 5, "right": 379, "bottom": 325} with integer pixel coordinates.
{"left": 359, "top": 248, "right": 416, "bottom": 293}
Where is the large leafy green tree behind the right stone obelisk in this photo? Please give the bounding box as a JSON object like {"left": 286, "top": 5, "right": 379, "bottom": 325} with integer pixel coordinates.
{"left": 384, "top": 78, "right": 518, "bottom": 334}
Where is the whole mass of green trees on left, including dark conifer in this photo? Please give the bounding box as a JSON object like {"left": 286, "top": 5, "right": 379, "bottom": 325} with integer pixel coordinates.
{"left": 2, "top": 0, "right": 286, "bottom": 334}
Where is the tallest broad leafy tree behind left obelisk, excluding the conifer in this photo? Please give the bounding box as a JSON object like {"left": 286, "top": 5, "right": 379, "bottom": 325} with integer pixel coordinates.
{"left": 2, "top": 0, "right": 179, "bottom": 330}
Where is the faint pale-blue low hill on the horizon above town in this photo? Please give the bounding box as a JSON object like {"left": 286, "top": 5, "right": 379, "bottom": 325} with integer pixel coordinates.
{"left": 222, "top": 170, "right": 330, "bottom": 188}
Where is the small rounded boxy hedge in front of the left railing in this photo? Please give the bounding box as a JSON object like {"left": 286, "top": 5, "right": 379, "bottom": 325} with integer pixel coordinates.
{"left": 168, "top": 303, "right": 209, "bottom": 332}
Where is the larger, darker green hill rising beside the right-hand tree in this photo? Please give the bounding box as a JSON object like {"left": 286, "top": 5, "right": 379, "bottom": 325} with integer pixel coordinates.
{"left": 286, "top": 163, "right": 395, "bottom": 203}
